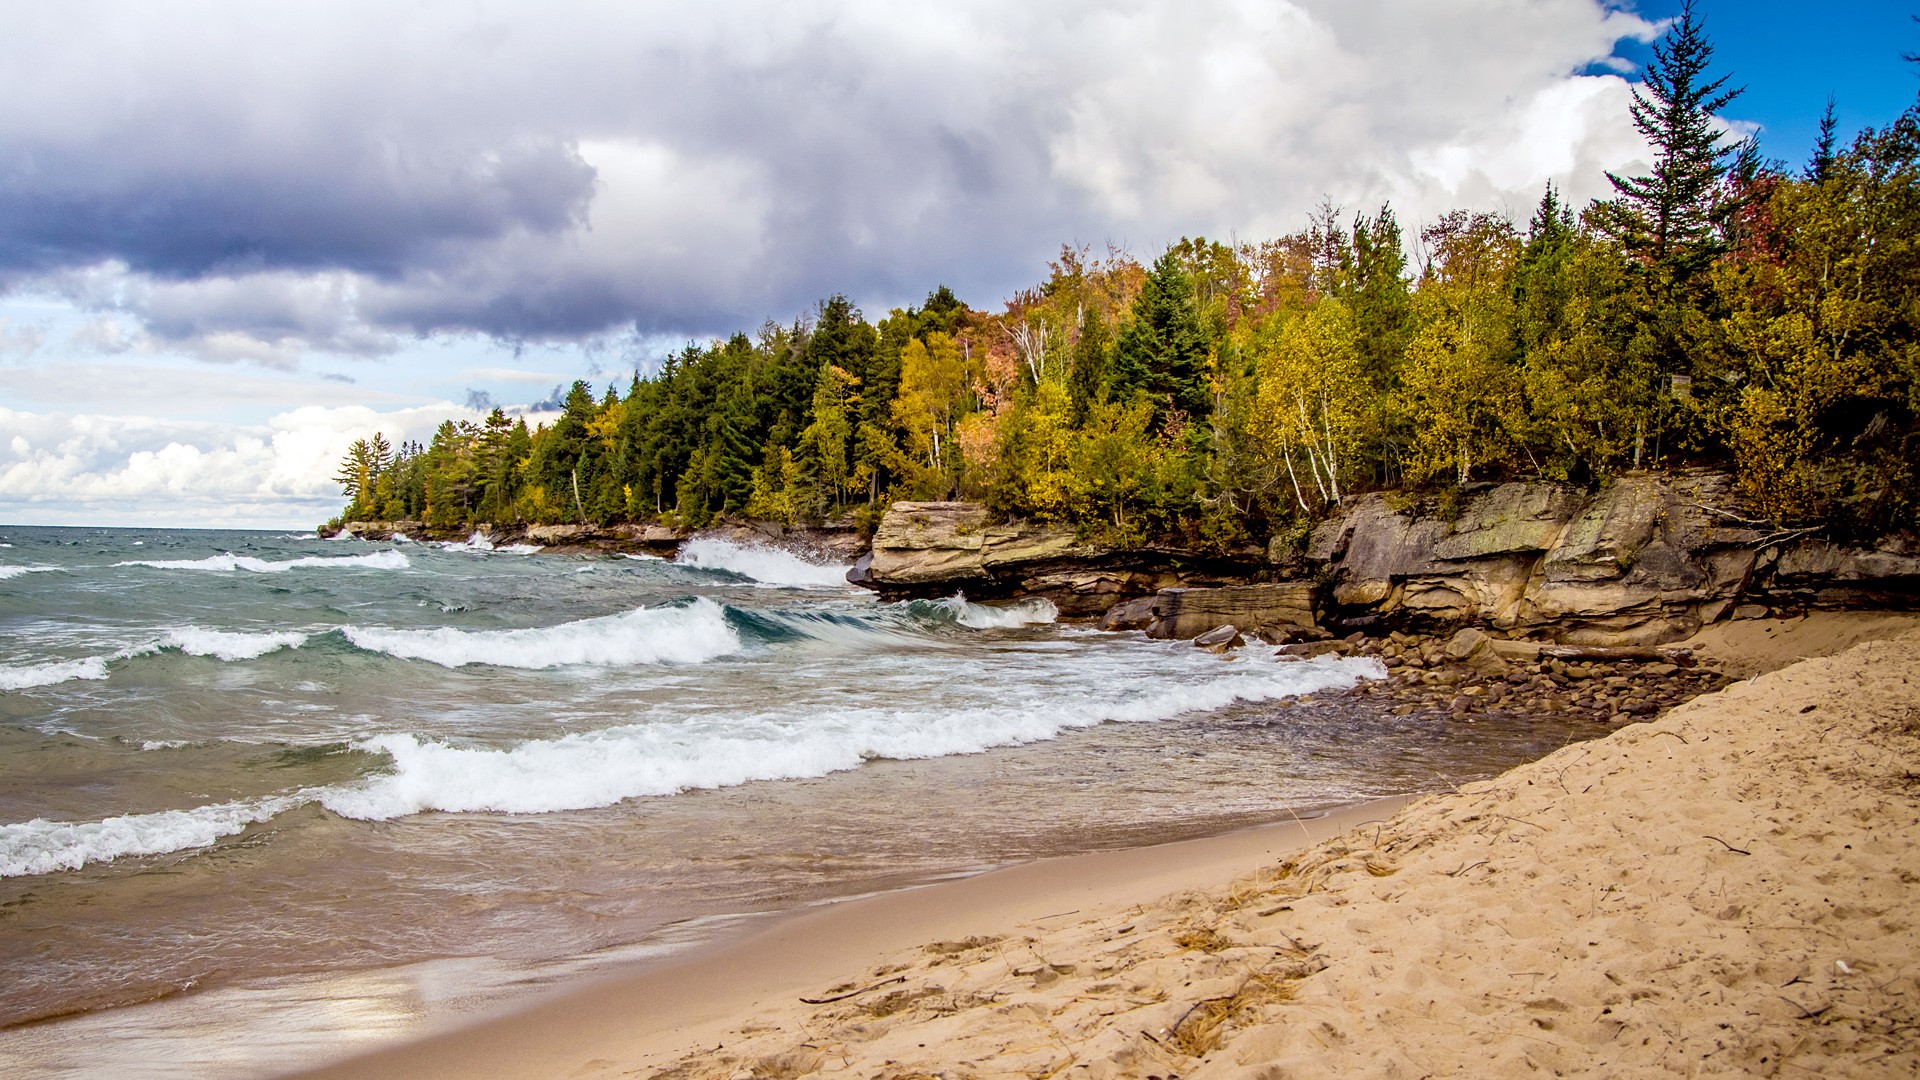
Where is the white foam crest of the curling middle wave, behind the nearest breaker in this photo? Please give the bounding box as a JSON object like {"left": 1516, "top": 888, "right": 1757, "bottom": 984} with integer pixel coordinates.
{"left": 340, "top": 600, "right": 741, "bottom": 669}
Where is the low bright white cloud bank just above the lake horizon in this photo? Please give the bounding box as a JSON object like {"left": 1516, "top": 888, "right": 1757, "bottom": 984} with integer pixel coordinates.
{"left": 0, "top": 402, "right": 480, "bottom": 528}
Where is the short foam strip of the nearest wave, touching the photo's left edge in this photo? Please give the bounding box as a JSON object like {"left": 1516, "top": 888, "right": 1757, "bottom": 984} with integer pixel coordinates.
{"left": 0, "top": 794, "right": 313, "bottom": 878}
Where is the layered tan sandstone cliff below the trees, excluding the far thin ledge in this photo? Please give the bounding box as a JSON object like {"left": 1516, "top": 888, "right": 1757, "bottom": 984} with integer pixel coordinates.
{"left": 856, "top": 471, "right": 1920, "bottom": 646}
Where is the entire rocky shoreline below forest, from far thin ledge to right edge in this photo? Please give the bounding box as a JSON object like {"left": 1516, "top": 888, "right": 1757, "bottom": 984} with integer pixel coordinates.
{"left": 323, "top": 471, "right": 1920, "bottom": 653}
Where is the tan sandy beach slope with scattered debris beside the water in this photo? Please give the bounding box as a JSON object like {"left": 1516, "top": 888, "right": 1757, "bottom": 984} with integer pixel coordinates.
{"left": 291, "top": 626, "right": 1920, "bottom": 1080}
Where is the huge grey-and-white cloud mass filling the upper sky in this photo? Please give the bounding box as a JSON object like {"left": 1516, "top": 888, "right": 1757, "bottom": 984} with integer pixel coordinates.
{"left": 0, "top": 0, "right": 1651, "bottom": 359}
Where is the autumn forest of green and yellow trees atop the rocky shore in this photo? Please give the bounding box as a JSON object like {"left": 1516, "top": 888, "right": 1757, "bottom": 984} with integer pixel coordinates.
{"left": 338, "top": 12, "right": 1920, "bottom": 546}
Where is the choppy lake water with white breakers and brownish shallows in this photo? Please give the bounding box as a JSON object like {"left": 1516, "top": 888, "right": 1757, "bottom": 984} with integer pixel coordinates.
{"left": 0, "top": 527, "right": 1592, "bottom": 1076}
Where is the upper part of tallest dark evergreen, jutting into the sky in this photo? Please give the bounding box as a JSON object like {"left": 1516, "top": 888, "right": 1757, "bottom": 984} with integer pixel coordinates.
{"left": 1596, "top": 0, "right": 1741, "bottom": 279}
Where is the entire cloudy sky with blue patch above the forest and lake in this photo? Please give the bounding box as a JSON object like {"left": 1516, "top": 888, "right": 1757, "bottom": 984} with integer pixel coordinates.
{"left": 0, "top": 0, "right": 1920, "bottom": 528}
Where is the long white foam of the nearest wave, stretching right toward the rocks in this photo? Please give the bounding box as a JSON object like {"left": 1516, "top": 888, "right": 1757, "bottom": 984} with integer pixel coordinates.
{"left": 321, "top": 645, "right": 1384, "bottom": 821}
